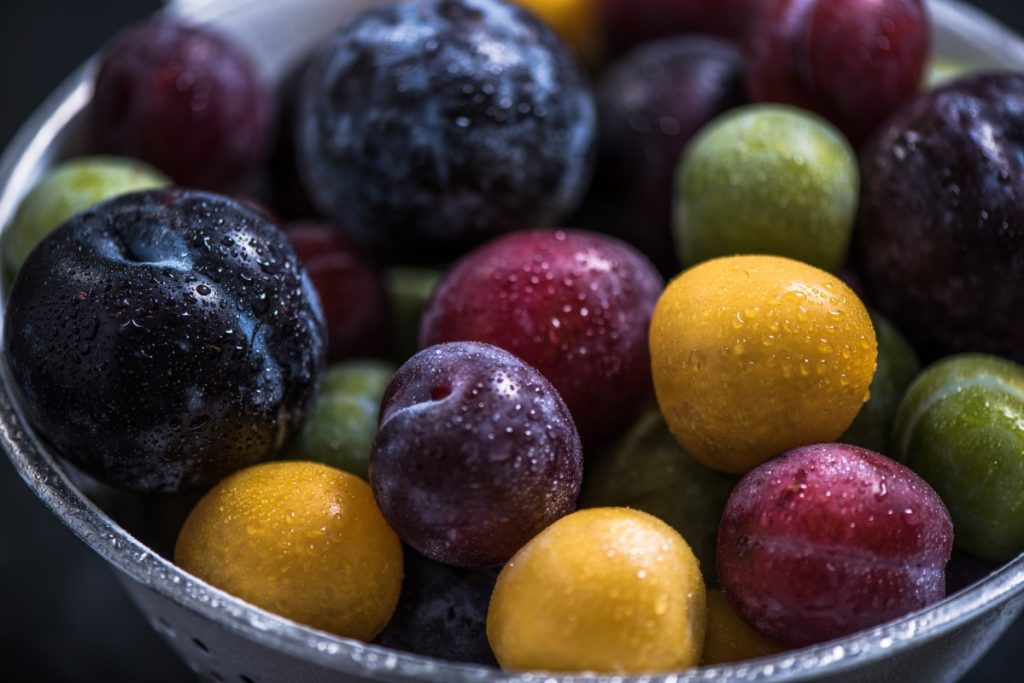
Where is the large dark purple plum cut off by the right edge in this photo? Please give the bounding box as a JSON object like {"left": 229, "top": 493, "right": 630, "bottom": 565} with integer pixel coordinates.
{"left": 855, "top": 74, "right": 1024, "bottom": 360}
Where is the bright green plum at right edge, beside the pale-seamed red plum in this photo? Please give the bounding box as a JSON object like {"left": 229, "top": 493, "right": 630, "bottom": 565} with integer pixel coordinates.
{"left": 893, "top": 354, "right": 1024, "bottom": 560}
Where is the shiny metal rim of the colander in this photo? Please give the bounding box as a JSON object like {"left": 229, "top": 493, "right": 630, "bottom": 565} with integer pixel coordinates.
{"left": 6, "top": 0, "right": 1024, "bottom": 683}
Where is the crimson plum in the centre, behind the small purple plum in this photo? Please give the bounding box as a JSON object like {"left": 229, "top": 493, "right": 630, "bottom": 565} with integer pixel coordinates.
{"left": 420, "top": 229, "right": 664, "bottom": 443}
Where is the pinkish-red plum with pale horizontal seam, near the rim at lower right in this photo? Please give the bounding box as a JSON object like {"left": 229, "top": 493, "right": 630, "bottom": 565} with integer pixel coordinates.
{"left": 718, "top": 444, "right": 953, "bottom": 647}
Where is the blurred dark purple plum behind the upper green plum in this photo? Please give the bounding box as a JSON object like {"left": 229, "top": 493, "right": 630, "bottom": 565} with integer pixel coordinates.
{"left": 591, "top": 38, "right": 744, "bottom": 275}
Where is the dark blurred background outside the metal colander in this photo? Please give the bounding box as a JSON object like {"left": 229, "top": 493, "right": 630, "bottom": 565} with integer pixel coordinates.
{"left": 0, "top": 0, "right": 1024, "bottom": 683}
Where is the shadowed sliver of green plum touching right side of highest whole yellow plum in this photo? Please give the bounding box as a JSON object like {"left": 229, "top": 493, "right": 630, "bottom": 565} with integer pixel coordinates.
{"left": 839, "top": 311, "right": 921, "bottom": 454}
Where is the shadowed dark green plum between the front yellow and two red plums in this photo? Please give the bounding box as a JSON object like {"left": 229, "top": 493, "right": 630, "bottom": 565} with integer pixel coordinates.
{"left": 580, "top": 411, "right": 739, "bottom": 586}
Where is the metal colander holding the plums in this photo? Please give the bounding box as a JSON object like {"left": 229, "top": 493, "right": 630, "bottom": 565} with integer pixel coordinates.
{"left": 0, "top": 0, "right": 1024, "bottom": 683}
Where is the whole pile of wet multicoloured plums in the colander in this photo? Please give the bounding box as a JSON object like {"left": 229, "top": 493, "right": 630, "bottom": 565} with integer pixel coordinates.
{"left": 0, "top": 0, "right": 1024, "bottom": 674}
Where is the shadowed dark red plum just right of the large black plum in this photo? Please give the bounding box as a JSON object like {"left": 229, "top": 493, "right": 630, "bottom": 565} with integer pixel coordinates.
{"left": 285, "top": 222, "right": 391, "bottom": 361}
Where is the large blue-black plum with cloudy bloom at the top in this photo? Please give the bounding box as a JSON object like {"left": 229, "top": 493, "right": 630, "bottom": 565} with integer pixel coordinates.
{"left": 298, "top": 0, "right": 596, "bottom": 262}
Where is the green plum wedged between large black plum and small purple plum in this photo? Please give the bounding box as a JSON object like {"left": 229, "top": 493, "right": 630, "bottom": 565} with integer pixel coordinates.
{"left": 286, "top": 360, "right": 397, "bottom": 479}
